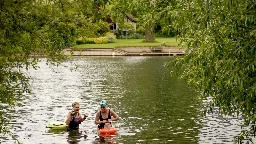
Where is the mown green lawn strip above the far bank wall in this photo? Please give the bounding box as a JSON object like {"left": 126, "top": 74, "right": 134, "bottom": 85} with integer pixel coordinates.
{"left": 74, "top": 37, "right": 178, "bottom": 49}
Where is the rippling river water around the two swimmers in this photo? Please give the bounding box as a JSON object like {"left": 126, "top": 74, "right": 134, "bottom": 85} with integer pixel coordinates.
{"left": 0, "top": 56, "right": 250, "bottom": 144}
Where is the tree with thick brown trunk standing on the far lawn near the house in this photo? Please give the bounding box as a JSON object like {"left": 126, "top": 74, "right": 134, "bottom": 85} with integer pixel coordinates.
{"left": 111, "top": 0, "right": 172, "bottom": 41}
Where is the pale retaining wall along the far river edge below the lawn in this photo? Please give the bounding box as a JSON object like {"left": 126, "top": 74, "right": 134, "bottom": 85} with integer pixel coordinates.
{"left": 63, "top": 46, "right": 185, "bottom": 56}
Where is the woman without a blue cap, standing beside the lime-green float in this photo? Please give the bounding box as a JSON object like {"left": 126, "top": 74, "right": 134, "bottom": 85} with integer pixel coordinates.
{"left": 66, "top": 102, "right": 88, "bottom": 131}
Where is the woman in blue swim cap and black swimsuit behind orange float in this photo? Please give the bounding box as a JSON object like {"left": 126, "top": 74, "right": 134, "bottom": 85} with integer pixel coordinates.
{"left": 95, "top": 100, "right": 119, "bottom": 129}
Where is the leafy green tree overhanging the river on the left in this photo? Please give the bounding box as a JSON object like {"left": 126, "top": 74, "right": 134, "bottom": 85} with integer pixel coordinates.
{"left": 0, "top": 0, "right": 90, "bottom": 139}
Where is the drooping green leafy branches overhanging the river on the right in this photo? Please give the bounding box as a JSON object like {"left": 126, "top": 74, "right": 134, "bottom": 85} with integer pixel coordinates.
{"left": 166, "top": 0, "right": 256, "bottom": 142}
